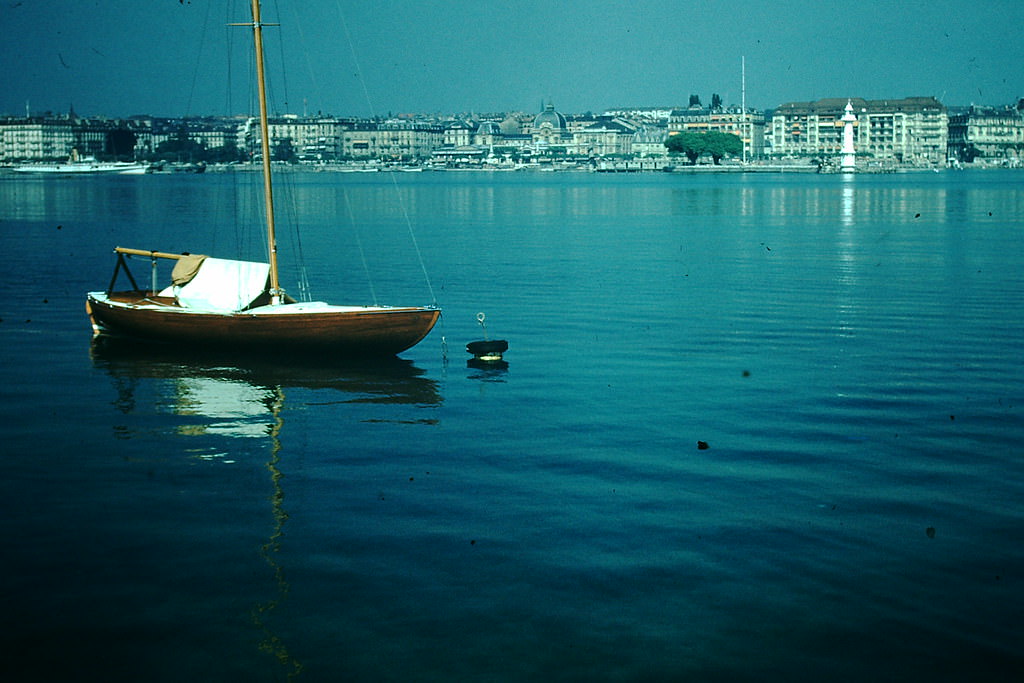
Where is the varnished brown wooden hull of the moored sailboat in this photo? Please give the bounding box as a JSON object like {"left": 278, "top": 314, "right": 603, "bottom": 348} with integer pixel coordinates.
{"left": 86, "top": 292, "right": 440, "bottom": 355}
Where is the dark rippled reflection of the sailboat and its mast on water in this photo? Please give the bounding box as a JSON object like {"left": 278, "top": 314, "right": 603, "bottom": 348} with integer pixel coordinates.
{"left": 91, "top": 337, "right": 441, "bottom": 680}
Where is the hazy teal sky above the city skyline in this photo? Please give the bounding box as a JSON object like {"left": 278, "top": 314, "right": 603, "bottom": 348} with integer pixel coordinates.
{"left": 0, "top": 0, "right": 1024, "bottom": 117}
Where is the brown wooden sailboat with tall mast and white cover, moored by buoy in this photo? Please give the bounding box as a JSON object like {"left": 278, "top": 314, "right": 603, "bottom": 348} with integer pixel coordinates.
{"left": 86, "top": 0, "right": 440, "bottom": 355}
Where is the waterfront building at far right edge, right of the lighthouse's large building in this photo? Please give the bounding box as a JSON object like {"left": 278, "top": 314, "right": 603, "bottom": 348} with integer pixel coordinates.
{"left": 948, "top": 99, "right": 1024, "bottom": 166}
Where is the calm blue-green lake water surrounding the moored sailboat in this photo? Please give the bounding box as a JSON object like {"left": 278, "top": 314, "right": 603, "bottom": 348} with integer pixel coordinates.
{"left": 0, "top": 171, "right": 1024, "bottom": 682}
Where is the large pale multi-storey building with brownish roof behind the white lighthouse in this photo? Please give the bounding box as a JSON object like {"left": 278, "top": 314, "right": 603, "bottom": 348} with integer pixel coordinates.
{"left": 768, "top": 97, "right": 948, "bottom": 166}
